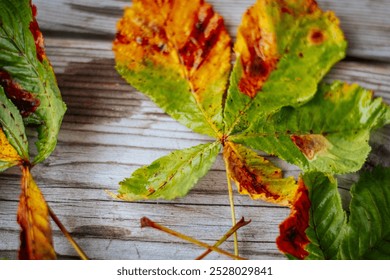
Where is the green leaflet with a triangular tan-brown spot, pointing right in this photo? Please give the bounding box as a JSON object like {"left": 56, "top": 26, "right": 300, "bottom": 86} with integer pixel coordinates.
{"left": 230, "top": 82, "right": 390, "bottom": 173}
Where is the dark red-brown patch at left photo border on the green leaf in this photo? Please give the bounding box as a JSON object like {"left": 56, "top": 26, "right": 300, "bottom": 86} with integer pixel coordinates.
{"left": 0, "top": 70, "right": 40, "bottom": 117}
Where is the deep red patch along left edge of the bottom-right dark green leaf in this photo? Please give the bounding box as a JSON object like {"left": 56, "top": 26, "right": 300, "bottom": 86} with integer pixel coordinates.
{"left": 276, "top": 179, "right": 311, "bottom": 259}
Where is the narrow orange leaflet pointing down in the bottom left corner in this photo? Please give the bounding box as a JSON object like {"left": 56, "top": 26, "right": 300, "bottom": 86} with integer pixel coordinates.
{"left": 18, "top": 167, "right": 56, "bottom": 260}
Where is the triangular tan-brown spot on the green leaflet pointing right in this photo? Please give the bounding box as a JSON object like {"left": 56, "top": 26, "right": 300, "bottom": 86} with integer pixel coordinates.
{"left": 290, "top": 134, "right": 328, "bottom": 160}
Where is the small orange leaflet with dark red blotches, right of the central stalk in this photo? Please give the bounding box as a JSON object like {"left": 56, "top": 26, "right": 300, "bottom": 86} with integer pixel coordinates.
{"left": 223, "top": 142, "right": 297, "bottom": 205}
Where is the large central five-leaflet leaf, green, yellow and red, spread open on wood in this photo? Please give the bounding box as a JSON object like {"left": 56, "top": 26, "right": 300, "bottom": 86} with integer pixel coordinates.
{"left": 113, "top": 0, "right": 390, "bottom": 258}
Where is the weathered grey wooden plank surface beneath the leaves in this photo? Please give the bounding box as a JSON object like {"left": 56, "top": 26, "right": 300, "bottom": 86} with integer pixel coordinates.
{"left": 0, "top": 0, "right": 390, "bottom": 259}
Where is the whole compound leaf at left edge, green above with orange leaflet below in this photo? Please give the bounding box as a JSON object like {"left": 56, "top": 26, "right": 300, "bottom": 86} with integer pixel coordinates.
{"left": 0, "top": 0, "right": 74, "bottom": 259}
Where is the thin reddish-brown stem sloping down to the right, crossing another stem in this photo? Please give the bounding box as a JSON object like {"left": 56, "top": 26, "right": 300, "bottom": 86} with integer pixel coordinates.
{"left": 141, "top": 217, "right": 245, "bottom": 260}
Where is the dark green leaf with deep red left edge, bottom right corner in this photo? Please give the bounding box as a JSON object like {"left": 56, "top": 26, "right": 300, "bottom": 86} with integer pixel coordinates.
{"left": 277, "top": 167, "right": 390, "bottom": 259}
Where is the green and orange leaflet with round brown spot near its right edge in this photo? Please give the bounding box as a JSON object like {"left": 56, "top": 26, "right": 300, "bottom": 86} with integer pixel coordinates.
{"left": 224, "top": 0, "right": 346, "bottom": 135}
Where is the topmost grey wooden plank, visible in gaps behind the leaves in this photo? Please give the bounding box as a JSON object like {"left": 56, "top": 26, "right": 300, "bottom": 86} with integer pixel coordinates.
{"left": 34, "top": 0, "right": 390, "bottom": 61}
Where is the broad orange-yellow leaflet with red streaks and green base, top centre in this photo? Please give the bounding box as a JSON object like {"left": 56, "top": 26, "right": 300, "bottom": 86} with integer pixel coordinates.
{"left": 114, "top": 0, "right": 231, "bottom": 137}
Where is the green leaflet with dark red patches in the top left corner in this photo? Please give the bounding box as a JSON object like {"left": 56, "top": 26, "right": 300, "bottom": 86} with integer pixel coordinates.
{"left": 0, "top": 0, "right": 66, "bottom": 163}
